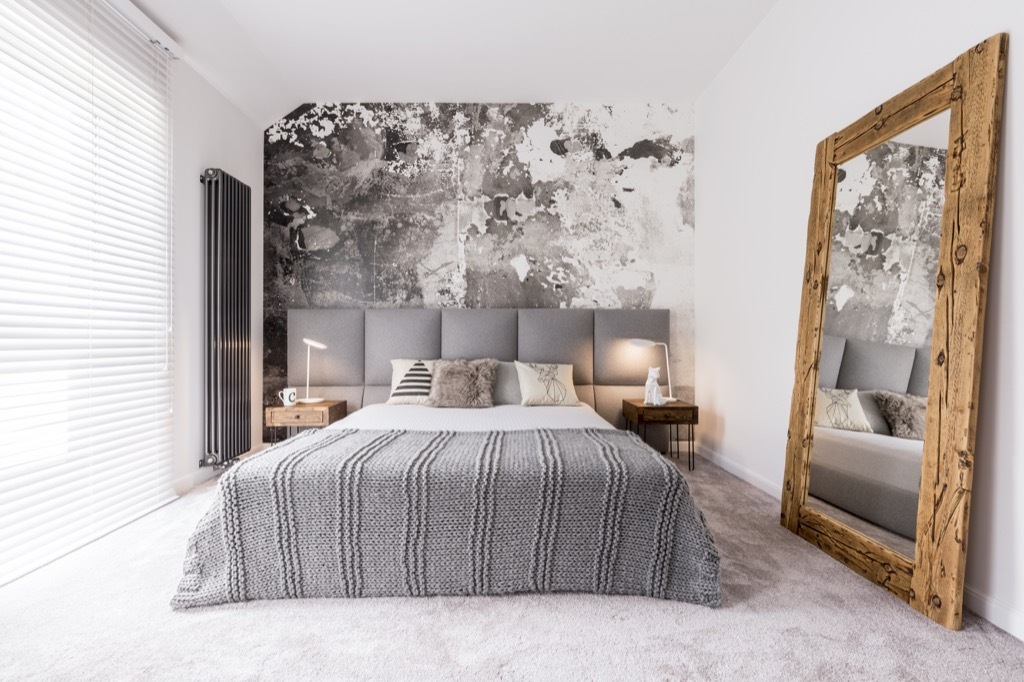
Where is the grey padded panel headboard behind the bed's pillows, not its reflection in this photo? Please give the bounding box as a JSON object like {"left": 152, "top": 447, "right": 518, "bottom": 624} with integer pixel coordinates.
{"left": 288, "top": 308, "right": 669, "bottom": 427}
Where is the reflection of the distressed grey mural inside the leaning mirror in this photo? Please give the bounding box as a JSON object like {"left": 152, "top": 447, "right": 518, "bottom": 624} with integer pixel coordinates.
{"left": 824, "top": 142, "right": 946, "bottom": 346}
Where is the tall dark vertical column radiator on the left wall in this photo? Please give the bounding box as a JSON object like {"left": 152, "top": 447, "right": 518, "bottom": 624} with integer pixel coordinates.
{"left": 200, "top": 168, "right": 252, "bottom": 465}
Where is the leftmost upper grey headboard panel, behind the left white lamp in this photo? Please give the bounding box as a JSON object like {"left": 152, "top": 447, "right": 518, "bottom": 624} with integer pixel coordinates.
{"left": 288, "top": 309, "right": 364, "bottom": 386}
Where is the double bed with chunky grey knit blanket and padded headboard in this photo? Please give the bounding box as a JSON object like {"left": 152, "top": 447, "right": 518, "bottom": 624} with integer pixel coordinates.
{"left": 172, "top": 310, "right": 721, "bottom": 608}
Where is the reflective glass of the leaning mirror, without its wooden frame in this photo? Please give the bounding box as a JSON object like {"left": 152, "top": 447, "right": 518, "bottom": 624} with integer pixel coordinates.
{"left": 807, "top": 111, "right": 949, "bottom": 558}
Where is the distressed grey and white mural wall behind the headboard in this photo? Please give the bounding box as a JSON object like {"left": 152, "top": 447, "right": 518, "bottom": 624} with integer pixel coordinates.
{"left": 264, "top": 103, "right": 693, "bottom": 413}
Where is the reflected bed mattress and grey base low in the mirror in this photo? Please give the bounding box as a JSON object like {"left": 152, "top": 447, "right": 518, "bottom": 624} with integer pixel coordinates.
{"left": 808, "top": 426, "right": 924, "bottom": 540}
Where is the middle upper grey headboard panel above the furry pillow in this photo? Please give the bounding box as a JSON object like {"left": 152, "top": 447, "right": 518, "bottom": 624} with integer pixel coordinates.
{"left": 440, "top": 308, "right": 519, "bottom": 361}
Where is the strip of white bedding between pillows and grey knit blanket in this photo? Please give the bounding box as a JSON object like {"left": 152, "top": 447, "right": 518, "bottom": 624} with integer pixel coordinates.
{"left": 327, "top": 404, "right": 614, "bottom": 431}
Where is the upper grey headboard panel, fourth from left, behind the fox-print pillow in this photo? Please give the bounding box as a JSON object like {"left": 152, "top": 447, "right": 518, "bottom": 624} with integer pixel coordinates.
{"left": 518, "top": 308, "right": 594, "bottom": 385}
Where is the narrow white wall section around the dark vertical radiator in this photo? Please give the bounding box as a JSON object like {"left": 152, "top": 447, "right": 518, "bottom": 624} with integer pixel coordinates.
{"left": 172, "top": 61, "right": 263, "bottom": 493}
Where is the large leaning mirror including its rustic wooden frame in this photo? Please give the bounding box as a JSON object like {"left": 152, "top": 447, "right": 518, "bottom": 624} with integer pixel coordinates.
{"left": 781, "top": 34, "right": 1008, "bottom": 629}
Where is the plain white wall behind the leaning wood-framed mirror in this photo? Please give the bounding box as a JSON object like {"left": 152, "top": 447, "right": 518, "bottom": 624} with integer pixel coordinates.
{"left": 695, "top": 0, "right": 1024, "bottom": 638}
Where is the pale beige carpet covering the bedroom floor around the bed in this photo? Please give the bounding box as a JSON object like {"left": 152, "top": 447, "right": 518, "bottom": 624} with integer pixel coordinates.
{"left": 0, "top": 460, "right": 1024, "bottom": 680}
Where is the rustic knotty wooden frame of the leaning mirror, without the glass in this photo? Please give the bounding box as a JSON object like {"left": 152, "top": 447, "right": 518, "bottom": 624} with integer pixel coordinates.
{"left": 781, "top": 34, "right": 1008, "bottom": 630}
